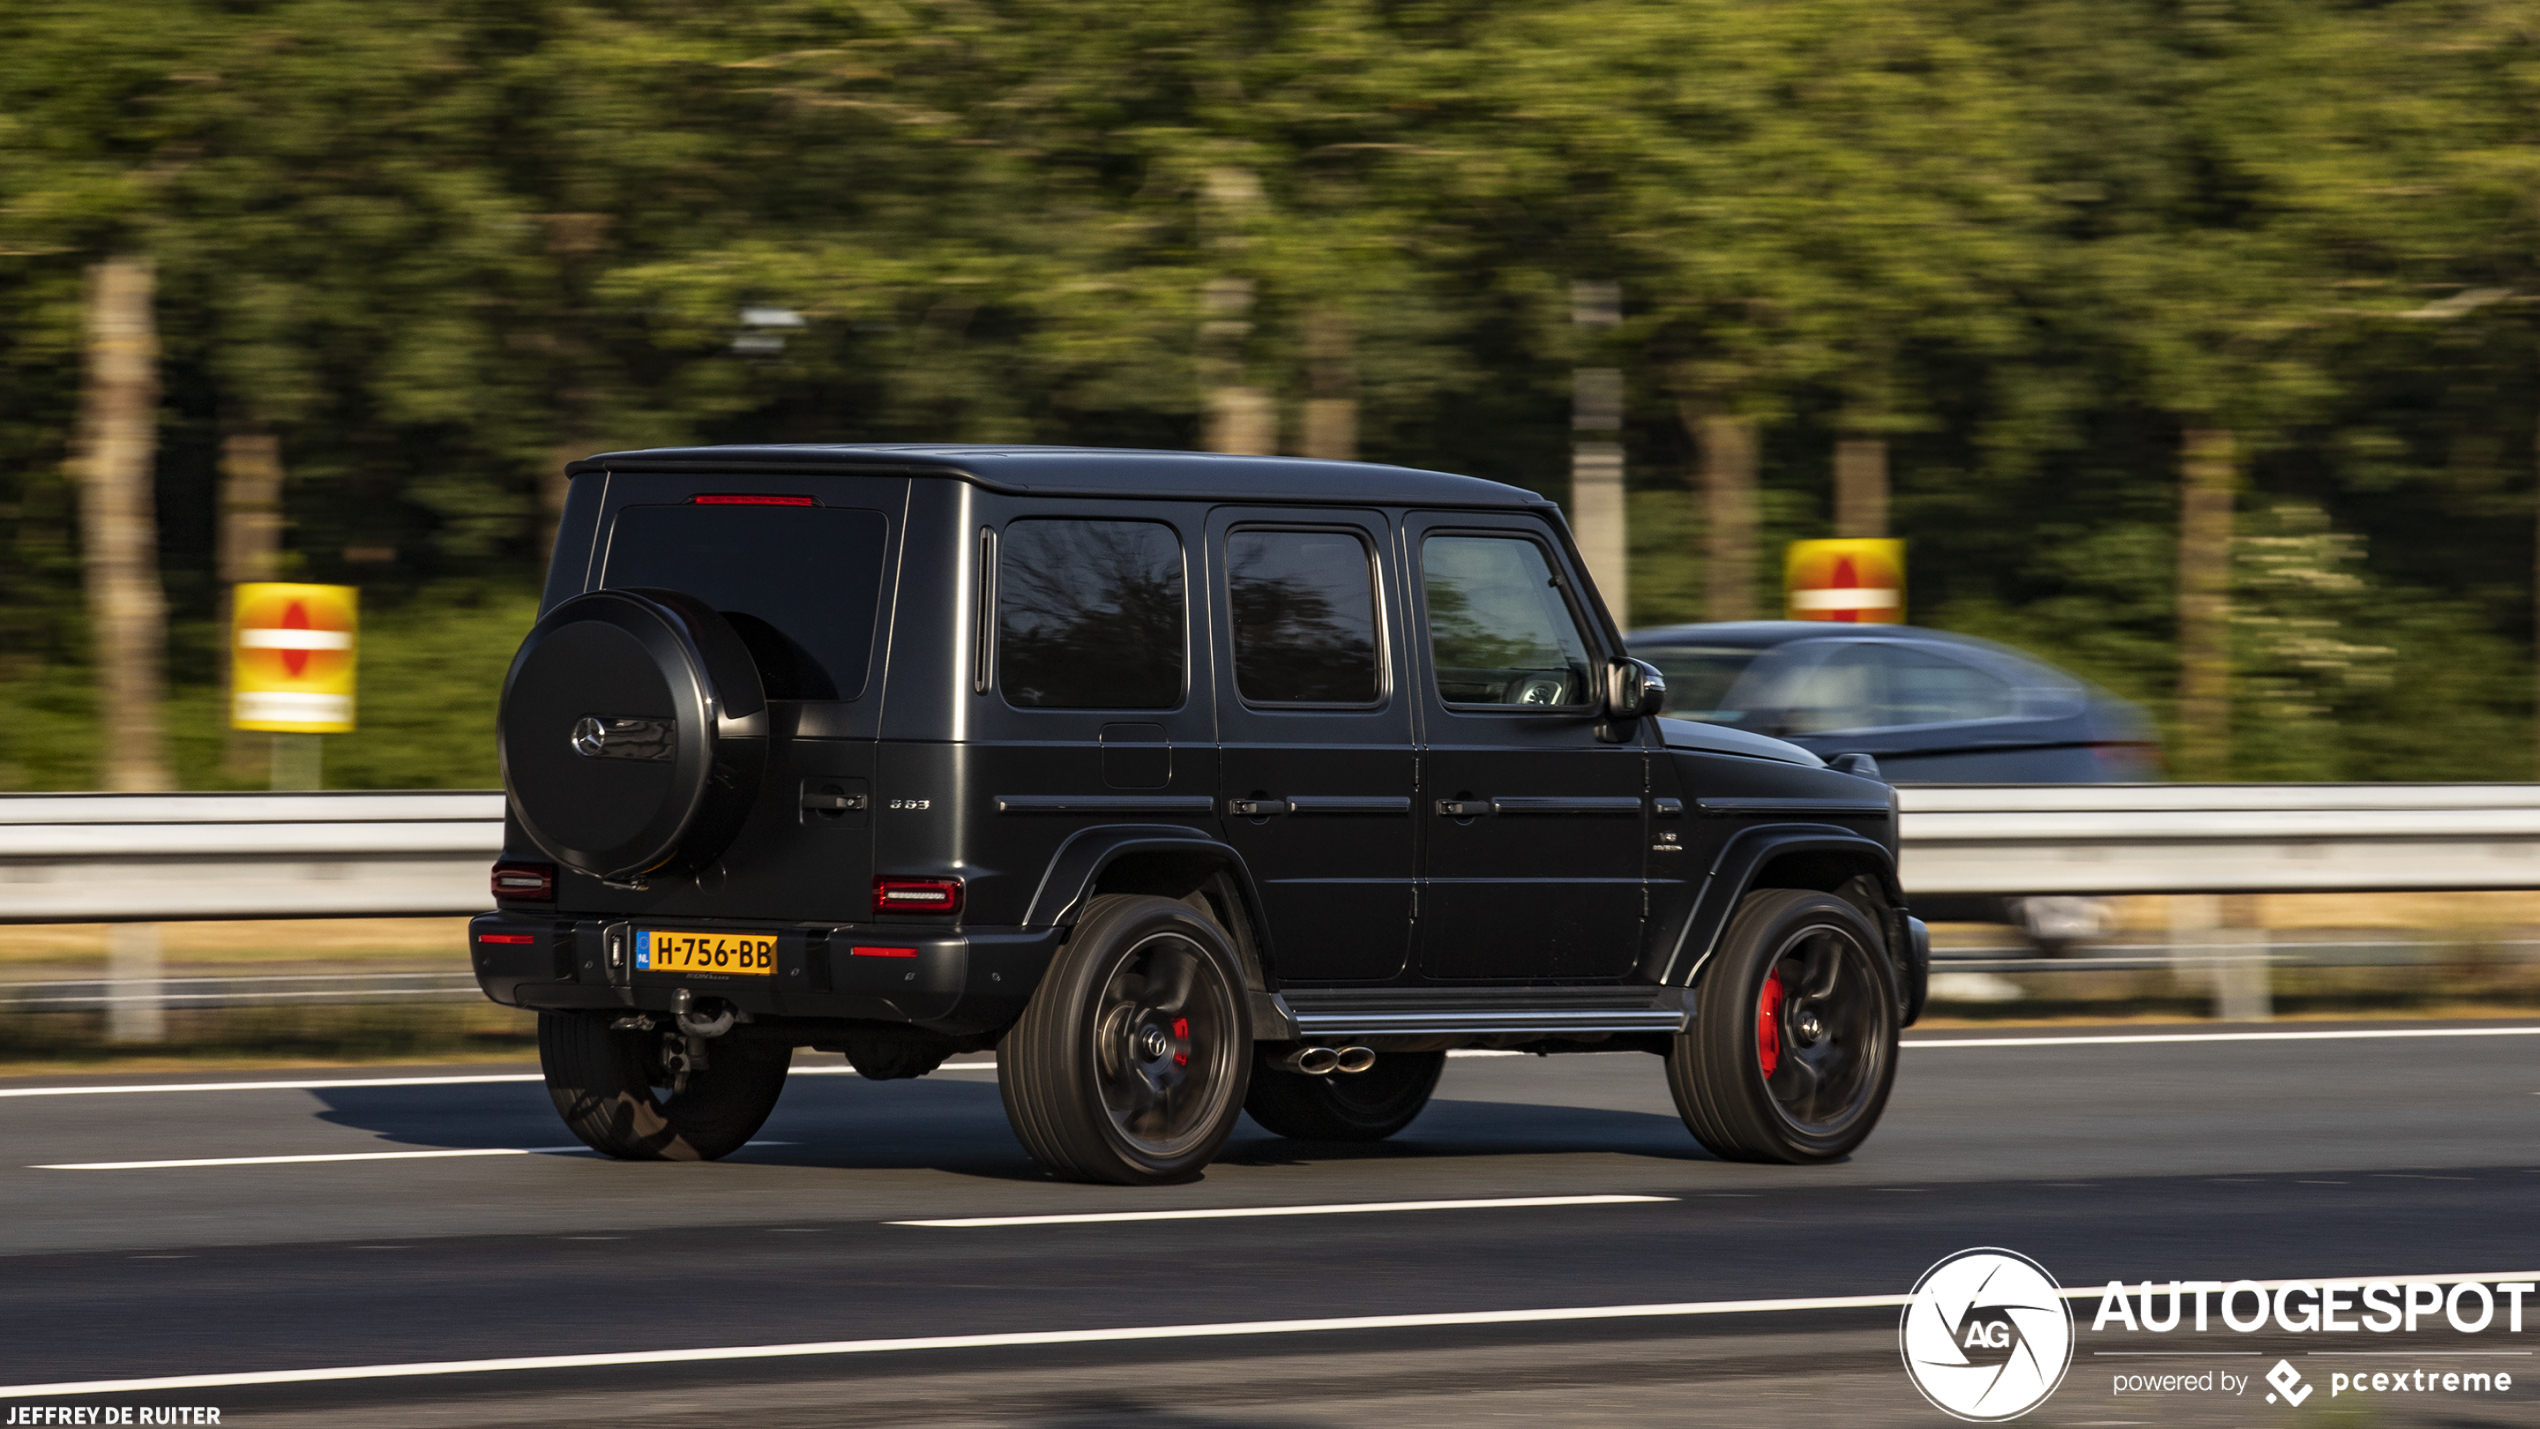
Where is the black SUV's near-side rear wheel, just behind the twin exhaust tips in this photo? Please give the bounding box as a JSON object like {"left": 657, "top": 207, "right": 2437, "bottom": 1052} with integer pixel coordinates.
{"left": 996, "top": 893, "right": 1252, "bottom": 1185}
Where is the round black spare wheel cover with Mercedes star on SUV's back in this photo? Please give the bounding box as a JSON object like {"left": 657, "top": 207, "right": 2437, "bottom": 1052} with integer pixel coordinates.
{"left": 495, "top": 589, "right": 767, "bottom": 883}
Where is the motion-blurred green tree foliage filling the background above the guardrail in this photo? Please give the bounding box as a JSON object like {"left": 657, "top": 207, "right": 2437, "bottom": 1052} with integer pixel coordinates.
{"left": 0, "top": 0, "right": 2540, "bottom": 787}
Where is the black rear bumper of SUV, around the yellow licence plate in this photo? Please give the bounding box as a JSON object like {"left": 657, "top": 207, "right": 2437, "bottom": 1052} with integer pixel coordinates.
{"left": 467, "top": 914, "right": 1067, "bottom": 1036}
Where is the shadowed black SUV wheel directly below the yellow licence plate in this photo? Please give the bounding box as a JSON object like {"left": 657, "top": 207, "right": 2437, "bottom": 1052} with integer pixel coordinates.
{"left": 538, "top": 1013, "right": 792, "bottom": 1160}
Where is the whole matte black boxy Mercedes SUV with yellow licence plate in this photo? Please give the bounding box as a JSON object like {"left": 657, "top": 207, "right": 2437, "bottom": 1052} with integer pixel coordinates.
{"left": 472, "top": 447, "right": 1928, "bottom": 1183}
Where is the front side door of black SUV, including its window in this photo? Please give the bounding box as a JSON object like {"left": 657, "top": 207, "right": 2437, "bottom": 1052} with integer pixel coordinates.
{"left": 1405, "top": 513, "right": 1651, "bottom": 982}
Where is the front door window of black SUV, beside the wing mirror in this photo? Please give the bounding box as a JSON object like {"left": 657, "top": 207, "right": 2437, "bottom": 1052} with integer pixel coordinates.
{"left": 1420, "top": 536, "right": 1590, "bottom": 706}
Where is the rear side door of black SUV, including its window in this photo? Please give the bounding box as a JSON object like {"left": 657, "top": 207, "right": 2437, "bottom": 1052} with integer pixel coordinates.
{"left": 1209, "top": 508, "right": 1415, "bottom": 982}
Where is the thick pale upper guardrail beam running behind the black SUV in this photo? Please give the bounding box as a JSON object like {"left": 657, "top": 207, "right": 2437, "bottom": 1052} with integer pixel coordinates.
{"left": 0, "top": 784, "right": 2540, "bottom": 924}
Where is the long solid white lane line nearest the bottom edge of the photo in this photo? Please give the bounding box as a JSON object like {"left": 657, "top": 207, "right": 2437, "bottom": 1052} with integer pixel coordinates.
{"left": 0, "top": 1269, "right": 2540, "bottom": 1399}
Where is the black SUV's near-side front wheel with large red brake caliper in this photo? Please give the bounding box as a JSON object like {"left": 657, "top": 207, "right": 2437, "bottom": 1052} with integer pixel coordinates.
{"left": 1666, "top": 888, "right": 1897, "bottom": 1162}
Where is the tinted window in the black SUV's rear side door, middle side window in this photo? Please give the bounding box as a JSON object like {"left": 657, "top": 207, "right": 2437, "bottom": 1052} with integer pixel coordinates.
{"left": 1227, "top": 530, "right": 1384, "bottom": 706}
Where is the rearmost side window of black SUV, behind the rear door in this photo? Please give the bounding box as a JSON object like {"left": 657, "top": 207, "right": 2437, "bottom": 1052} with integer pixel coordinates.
{"left": 996, "top": 520, "right": 1186, "bottom": 711}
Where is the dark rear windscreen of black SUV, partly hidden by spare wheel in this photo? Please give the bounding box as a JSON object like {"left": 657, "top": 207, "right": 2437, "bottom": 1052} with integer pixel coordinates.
{"left": 599, "top": 505, "right": 889, "bottom": 701}
